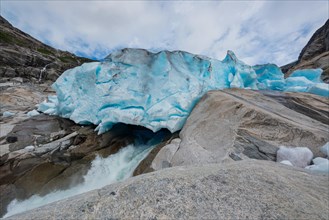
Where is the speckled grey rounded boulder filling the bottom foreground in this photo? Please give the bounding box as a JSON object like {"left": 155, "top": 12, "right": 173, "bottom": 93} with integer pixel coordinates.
{"left": 5, "top": 160, "right": 329, "bottom": 219}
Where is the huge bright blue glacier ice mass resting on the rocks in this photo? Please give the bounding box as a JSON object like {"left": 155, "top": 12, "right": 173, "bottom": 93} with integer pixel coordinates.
{"left": 38, "top": 49, "right": 329, "bottom": 134}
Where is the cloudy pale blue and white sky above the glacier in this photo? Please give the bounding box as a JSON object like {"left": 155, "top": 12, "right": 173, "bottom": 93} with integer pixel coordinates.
{"left": 0, "top": 0, "right": 329, "bottom": 66}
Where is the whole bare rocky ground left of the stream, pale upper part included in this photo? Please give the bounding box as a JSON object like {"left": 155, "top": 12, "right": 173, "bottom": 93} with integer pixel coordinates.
{"left": 0, "top": 79, "right": 140, "bottom": 215}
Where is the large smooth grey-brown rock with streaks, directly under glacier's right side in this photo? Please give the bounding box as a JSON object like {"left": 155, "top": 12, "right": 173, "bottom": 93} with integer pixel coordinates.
{"left": 152, "top": 89, "right": 329, "bottom": 170}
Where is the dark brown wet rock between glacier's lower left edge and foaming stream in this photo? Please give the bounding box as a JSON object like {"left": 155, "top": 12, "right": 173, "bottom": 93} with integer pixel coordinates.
{"left": 0, "top": 114, "right": 134, "bottom": 214}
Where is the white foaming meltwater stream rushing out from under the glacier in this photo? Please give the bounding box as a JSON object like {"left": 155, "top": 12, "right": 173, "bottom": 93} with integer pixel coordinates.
{"left": 3, "top": 145, "right": 152, "bottom": 217}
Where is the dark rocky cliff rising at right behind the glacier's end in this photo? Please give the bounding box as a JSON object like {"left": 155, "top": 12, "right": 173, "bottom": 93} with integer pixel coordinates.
{"left": 281, "top": 20, "right": 329, "bottom": 83}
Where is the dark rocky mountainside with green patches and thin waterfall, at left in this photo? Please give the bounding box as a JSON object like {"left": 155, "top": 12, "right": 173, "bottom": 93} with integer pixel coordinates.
{"left": 0, "top": 16, "right": 91, "bottom": 81}
